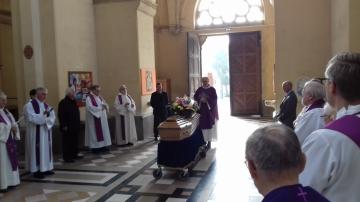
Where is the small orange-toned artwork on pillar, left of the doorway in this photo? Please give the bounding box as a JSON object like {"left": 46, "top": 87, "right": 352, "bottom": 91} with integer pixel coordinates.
{"left": 140, "top": 69, "right": 156, "bottom": 95}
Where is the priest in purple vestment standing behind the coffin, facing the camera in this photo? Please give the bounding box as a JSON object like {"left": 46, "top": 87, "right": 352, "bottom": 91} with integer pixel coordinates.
{"left": 194, "top": 77, "right": 219, "bottom": 149}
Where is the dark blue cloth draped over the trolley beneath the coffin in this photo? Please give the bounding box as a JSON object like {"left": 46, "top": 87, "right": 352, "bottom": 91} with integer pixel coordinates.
{"left": 157, "top": 127, "right": 205, "bottom": 168}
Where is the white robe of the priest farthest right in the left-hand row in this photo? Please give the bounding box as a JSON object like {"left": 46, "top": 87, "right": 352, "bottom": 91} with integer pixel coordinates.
{"left": 114, "top": 93, "right": 137, "bottom": 145}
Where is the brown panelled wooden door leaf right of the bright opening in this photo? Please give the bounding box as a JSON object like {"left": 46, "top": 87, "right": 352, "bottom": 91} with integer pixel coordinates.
{"left": 229, "top": 32, "right": 262, "bottom": 116}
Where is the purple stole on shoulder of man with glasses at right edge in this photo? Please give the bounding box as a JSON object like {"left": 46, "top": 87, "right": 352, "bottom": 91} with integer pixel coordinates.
{"left": 325, "top": 113, "right": 360, "bottom": 149}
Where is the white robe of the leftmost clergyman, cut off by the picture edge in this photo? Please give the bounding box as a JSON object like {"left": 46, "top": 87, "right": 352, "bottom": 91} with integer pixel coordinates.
{"left": 0, "top": 109, "right": 20, "bottom": 189}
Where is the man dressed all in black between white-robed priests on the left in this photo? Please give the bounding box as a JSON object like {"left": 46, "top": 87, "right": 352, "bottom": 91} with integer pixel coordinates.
{"left": 58, "top": 88, "right": 81, "bottom": 163}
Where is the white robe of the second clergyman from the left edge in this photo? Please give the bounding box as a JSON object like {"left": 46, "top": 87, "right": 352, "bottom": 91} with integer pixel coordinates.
{"left": 26, "top": 99, "right": 56, "bottom": 173}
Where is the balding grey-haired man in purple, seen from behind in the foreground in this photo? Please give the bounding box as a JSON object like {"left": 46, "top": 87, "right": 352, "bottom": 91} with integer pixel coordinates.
{"left": 245, "top": 124, "right": 329, "bottom": 202}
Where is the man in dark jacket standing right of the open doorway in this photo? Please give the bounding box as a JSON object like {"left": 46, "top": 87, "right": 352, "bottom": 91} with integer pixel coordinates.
{"left": 275, "top": 81, "right": 297, "bottom": 129}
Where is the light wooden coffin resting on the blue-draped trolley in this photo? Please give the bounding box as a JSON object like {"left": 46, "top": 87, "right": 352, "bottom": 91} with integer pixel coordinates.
{"left": 158, "top": 113, "right": 200, "bottom": 141}
